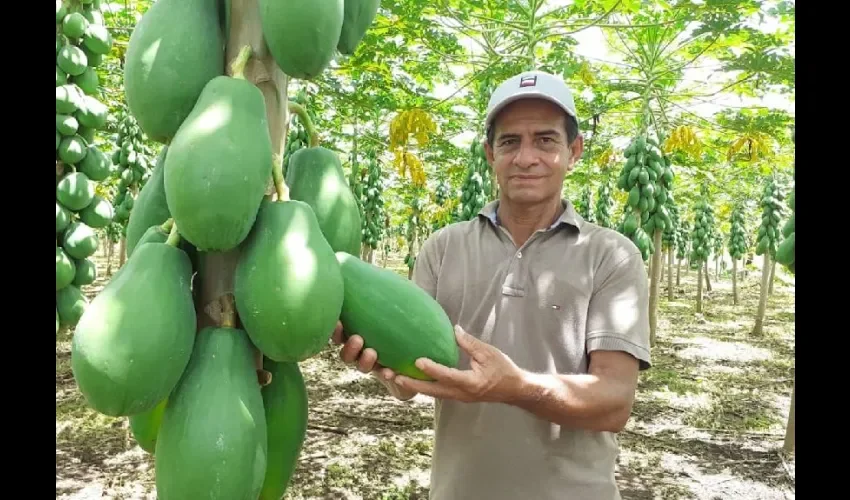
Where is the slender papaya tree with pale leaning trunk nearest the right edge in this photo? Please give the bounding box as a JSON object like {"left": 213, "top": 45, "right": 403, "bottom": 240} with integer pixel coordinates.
{"left": 751, "top": 172, "right": 784, "bottom": 336}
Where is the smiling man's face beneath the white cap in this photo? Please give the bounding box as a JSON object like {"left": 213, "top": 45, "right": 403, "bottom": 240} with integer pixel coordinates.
{"left": 485, "top": 99, "right": 584, "bottom": 204}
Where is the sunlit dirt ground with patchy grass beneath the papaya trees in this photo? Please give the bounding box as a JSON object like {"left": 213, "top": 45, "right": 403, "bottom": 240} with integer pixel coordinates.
{"left": 56, "top": 246, "right": 795, "bottom": 500}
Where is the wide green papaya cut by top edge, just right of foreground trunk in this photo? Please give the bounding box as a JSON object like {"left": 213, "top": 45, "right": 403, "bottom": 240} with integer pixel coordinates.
{"left": 259, "top": 0, "right": 345, "bottom": 80}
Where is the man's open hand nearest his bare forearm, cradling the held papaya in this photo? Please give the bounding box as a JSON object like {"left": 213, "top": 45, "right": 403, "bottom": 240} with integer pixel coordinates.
{"left": 394, "top": 325, "right": 523, "bottom": 403}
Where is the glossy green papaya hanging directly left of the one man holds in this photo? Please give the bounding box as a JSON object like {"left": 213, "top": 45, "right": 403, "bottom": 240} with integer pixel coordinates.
{"left": 233, "top": 200, "right": 343, "bottom": 362}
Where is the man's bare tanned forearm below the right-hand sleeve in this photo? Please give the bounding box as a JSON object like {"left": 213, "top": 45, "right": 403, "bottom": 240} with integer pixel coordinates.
{"left": 507, "top": 372, "right": 634, "bottom": 432}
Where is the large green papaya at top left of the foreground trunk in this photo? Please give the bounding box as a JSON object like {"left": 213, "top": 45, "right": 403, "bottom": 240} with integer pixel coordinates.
{"left": 124, "top": 0, "right": 224, "bottom": 143}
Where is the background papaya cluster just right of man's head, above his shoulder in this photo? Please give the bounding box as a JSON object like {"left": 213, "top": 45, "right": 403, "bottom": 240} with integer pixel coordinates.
{"left": 617, "top": 134, "right": 673, "bottom": 260}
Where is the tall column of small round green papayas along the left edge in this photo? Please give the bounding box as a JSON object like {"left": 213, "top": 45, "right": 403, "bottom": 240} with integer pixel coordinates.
{"left": 56, "top": 0, "right": 113, "bottom": 333}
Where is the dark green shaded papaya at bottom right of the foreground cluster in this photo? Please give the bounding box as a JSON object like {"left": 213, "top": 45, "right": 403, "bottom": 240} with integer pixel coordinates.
{"left": 259, "top": 358, "right": 308, "bottom": 500}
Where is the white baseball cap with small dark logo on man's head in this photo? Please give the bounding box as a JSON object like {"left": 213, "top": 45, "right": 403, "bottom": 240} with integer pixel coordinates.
{"left": 484, "top": 71, "right": 578, "bottom": 130}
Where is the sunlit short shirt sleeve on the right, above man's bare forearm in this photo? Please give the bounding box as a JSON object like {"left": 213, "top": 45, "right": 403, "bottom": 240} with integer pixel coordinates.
{"left": 586, "top": 253, "right": 651, "bottom": 370}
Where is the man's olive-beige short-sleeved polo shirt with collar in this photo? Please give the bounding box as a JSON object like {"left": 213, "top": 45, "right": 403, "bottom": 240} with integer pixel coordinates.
{"left": 413, "top": 200, "right": 650, "bottom": 500}
